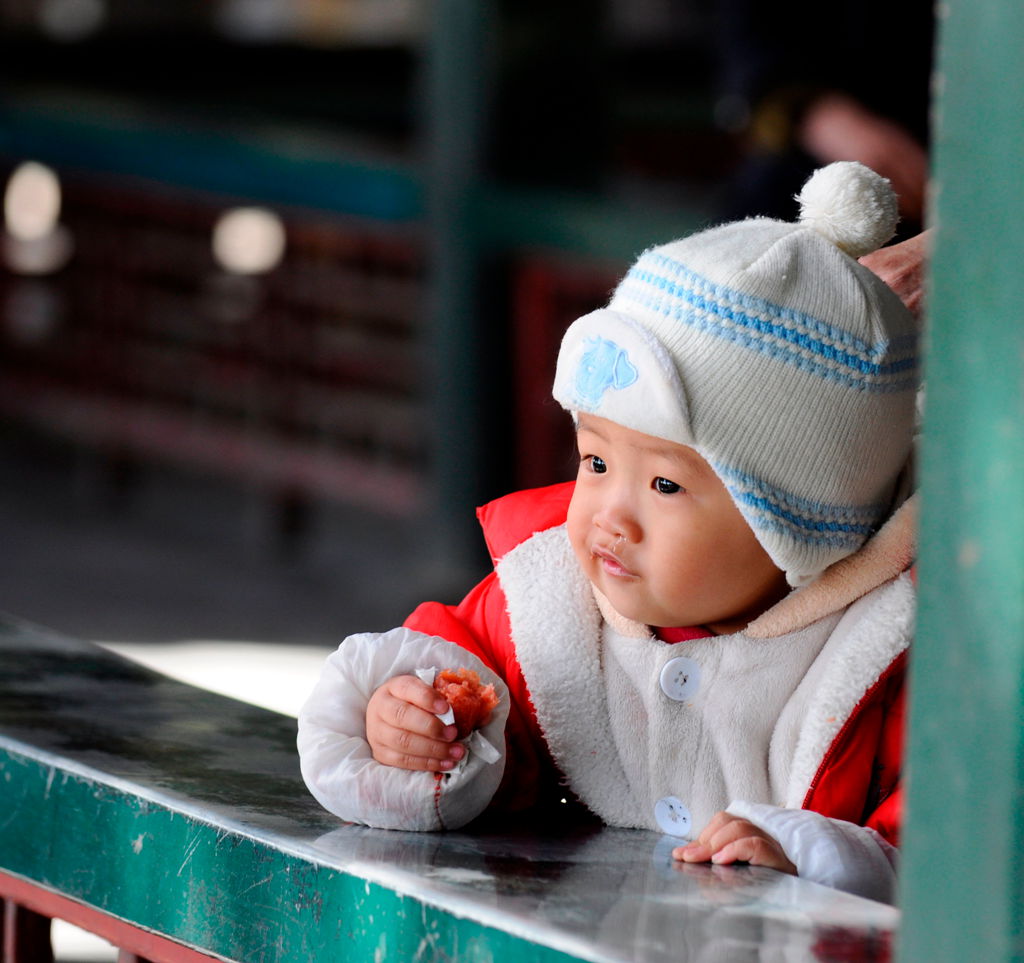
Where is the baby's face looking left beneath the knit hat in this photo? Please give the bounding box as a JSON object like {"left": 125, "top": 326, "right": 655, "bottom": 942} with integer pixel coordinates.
{"left": 568, "top": 414, "right": 788, "bottom": 634}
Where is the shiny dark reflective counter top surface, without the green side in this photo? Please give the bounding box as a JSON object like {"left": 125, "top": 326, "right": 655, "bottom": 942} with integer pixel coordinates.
{"left": 0, "top": 618, "right": 898, "bottom": 963}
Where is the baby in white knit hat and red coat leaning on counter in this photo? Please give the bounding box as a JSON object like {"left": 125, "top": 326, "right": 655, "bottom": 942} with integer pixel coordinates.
{"left": 298, "top": 163, "right": 918, "bottom": 899}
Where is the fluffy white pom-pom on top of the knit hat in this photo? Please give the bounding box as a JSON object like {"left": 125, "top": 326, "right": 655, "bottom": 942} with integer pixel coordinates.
{"left": 797, "top": 161, "right": 899, "bottom": 257}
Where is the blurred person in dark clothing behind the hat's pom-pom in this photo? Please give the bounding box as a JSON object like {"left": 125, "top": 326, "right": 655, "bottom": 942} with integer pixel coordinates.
{"left": 715, "top": 0, "right": 934, "bottom": 239}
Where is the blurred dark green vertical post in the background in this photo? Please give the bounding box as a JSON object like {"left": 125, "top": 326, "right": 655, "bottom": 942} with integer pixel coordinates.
{"left": 422, "top": 0, "right": 492, "bottom": 578}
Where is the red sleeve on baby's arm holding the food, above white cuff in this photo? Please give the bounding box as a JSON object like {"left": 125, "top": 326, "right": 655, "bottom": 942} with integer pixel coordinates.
{"left": 404, "top": 573, "right": 559, "bottom": 810}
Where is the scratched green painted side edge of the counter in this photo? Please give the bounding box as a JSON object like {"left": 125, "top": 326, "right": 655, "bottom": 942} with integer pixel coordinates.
{"left": 0, "top": 746, "right": 589, "bottom": 963}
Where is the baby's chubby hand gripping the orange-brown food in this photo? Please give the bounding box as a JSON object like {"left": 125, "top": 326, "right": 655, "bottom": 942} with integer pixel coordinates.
{"left": 367, "top": 675, "right": 466, "bottom": 772}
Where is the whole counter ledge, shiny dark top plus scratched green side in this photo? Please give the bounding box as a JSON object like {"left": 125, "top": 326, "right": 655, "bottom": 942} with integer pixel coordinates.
{"left": 0, "top": 619, "right": 899, "bottom": 963}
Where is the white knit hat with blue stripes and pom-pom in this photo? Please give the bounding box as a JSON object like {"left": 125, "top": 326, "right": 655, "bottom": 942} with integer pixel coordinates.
{"left": 554, "top": 162, "right": 919, "bottom": 585}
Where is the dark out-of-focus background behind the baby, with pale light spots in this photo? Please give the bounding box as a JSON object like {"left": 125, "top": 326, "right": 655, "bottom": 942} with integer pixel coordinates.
{"left": 0, "top": 0, "right": 931, "bottom": 958}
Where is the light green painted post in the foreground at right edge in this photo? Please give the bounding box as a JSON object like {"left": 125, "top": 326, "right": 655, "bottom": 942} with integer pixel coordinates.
{"left": 900, "top": 0, "right": 1024, "bottom": 963}
